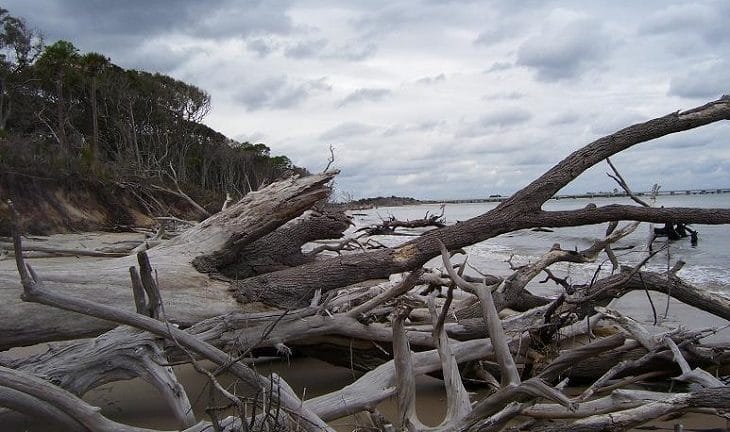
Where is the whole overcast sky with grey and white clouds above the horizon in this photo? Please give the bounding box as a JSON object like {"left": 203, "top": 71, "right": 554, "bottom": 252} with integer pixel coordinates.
{"left": 3, "top": 0, "right": 730, "bottom": 199}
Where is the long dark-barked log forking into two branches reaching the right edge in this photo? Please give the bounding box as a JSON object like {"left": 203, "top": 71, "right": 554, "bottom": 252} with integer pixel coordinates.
{"left": 236, "top": 96, "right": 730, "bottom": 307}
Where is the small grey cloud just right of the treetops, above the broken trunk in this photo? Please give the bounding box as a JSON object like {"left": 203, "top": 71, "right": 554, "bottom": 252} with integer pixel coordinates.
{"left": 236, "top": 76, "right": 332, "bottom": 111}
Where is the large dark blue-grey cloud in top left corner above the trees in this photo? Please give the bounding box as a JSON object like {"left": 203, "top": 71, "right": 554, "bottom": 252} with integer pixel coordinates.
{"left": 4, "top": 0, "right": 293, "bottom": 71}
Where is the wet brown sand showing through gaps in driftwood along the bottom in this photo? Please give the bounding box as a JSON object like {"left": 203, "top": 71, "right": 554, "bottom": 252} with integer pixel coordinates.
{"left": 7, "top": 351, "right": 730, "bottom": 432}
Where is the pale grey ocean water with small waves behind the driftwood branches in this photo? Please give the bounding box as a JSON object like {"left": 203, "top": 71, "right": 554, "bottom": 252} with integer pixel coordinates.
{"left": 346, "top": 194, "right": 730, "bottom": 295}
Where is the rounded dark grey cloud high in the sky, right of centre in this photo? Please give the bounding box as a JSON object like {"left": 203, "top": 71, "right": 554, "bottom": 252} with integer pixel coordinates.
{"left": 517, "top": 19, "right": 610, "bottom": 82}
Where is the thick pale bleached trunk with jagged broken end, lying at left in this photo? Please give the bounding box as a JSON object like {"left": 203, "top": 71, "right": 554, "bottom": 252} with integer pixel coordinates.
{"left": 0, "top": 173, "right": 335, "bottom": 349}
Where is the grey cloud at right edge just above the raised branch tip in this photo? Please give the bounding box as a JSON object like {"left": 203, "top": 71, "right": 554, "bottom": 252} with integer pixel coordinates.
{"left": 669, "top": 60, "right": 730, "bottom": 99}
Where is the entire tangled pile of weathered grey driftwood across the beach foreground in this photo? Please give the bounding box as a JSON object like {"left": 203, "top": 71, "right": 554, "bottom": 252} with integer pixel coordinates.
{"left": 0, "top": 97, "right": 730, "bottom": 431}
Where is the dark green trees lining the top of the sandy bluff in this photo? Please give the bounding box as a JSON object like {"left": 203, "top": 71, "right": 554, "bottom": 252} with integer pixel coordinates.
{"left": 0, "top": 8, "right": 303, "bottom": 194}
